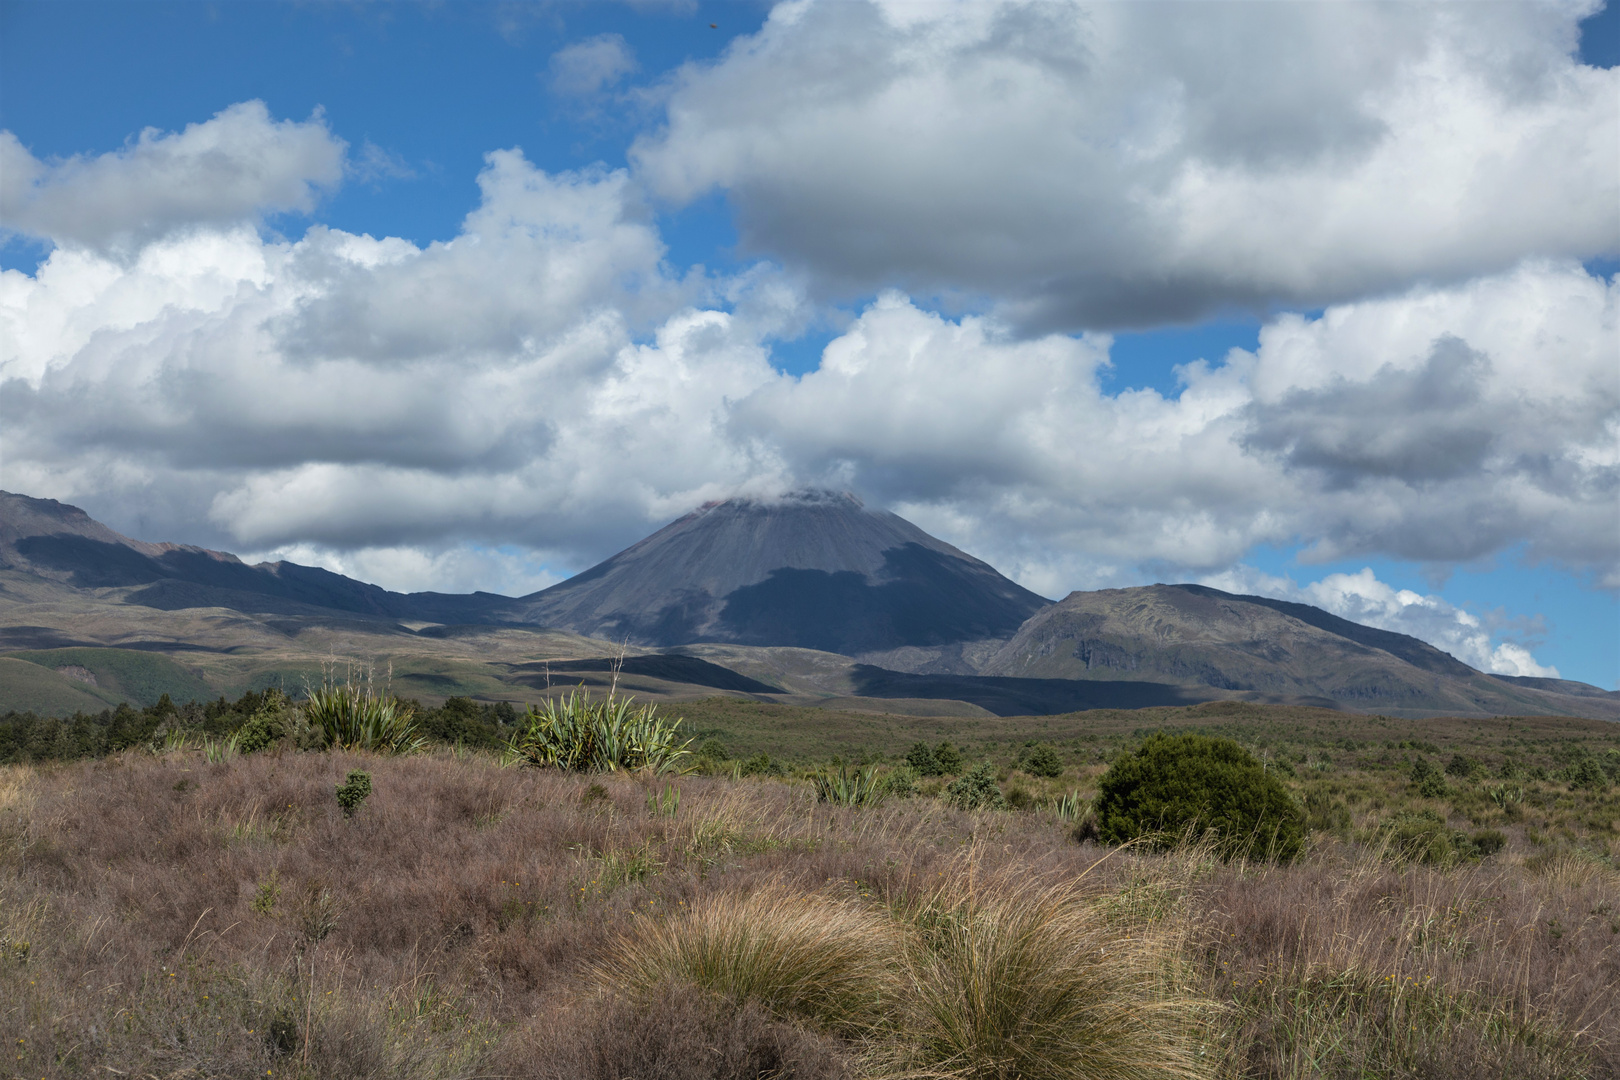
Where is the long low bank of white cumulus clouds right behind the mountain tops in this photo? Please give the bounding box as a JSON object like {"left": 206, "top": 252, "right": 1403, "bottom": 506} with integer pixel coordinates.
{"left": 0, "top": 99, "right": 1620, "bottom": 674}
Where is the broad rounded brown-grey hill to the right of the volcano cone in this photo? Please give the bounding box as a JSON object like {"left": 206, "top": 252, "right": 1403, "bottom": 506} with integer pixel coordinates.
{"left": 980, "top": 585, "right": 1620, "bottom": 719}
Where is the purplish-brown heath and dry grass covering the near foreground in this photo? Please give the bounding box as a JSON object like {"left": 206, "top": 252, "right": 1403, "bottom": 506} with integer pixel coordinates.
{"left": 0, "top": 751, "right": 1620, "bottom": 1080}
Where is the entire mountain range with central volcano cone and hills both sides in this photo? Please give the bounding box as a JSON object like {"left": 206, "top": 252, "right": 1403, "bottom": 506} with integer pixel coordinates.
{"left": 0, "top": 491, "right": 1620, "bottom": 719}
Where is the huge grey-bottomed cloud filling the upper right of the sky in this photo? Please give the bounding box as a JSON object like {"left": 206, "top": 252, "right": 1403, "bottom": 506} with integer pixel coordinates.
{"left": 633, "top": 0, "right": 1620, "bottom": 329}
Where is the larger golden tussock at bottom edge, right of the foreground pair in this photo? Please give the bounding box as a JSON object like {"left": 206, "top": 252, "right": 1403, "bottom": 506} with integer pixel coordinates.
{"left": 901, "top": 876, "right": 1213, "bottom": 1080}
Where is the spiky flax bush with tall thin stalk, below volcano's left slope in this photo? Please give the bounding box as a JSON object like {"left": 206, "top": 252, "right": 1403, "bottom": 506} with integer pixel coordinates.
{"left": 509, "top": 688, "right": 692, "bottom": 774}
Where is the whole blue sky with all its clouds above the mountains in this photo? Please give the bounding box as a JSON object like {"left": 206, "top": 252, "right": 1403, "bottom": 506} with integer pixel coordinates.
{"left": 0, "top": 3, "right": 1620, "bottom": 688}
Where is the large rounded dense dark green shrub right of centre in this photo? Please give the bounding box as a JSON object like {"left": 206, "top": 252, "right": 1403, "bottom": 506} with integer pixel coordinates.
{"left": 1097, "top": 735, "right": 1304, "bottom": 861}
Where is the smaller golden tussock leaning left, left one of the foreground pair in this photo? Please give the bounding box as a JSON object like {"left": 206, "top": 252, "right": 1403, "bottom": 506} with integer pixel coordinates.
{"left": 596, "top": 886, "right": 901, "bottom": 1035}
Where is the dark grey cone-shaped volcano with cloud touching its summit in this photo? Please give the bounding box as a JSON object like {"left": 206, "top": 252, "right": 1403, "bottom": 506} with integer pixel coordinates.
{"left": 523, "top": 492, "right": 1050, "bottom": 656}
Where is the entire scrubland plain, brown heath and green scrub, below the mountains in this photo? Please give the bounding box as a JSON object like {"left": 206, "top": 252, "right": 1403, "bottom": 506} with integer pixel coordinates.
{"left": 0, "top": 689, "right": 1620, "bottom": 1080}
